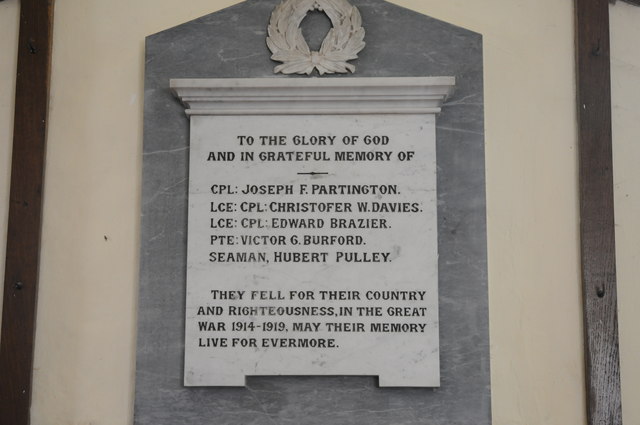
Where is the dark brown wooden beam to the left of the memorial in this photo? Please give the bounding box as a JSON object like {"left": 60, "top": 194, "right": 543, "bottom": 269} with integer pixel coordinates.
{"left": 0, "top": 0, "right": 53, "bottom": 425}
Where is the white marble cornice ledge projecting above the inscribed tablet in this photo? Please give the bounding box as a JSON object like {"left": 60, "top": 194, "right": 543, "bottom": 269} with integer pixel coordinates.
{"left": 170, "top": 77, "right": 455, "bottom": 116}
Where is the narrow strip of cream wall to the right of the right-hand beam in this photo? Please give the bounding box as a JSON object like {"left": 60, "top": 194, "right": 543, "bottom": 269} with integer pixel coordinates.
{"left": 611, "top": 2, "right": 640, "bottom": 425}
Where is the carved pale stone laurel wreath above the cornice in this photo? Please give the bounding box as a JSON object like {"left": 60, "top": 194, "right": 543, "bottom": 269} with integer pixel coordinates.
{"left": 267, "top": 0, "right": 365, "bottom": 75}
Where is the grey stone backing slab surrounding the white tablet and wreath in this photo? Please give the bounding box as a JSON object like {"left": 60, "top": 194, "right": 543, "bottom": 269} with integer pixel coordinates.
{"left": 134, "top": 0, "right": 491, "bottom": 425}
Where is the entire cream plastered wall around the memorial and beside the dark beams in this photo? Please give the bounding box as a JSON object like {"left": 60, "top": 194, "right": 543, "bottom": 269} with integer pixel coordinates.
{"left": 0, "top": 0, "right": 640, "bottom": 425}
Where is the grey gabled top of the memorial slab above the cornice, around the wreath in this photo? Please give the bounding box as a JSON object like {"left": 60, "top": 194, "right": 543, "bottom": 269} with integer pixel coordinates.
{"left": 146, "top": 0, "right": 482, "bottom": 78}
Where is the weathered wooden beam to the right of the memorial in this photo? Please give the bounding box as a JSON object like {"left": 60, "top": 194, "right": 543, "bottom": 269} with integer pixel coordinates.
{"left": 576, "top": 0, "right": 622, "bottom": 425}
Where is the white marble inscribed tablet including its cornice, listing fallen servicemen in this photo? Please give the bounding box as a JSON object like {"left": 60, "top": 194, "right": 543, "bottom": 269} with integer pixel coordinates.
{"left": 172, "top": 77, "right": 454, "bottom": 387}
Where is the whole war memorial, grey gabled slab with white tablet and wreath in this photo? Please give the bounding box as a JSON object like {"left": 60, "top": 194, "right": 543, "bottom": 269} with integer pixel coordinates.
{"left": 134, "top": 0, "right": 491, "bottom": 425}
